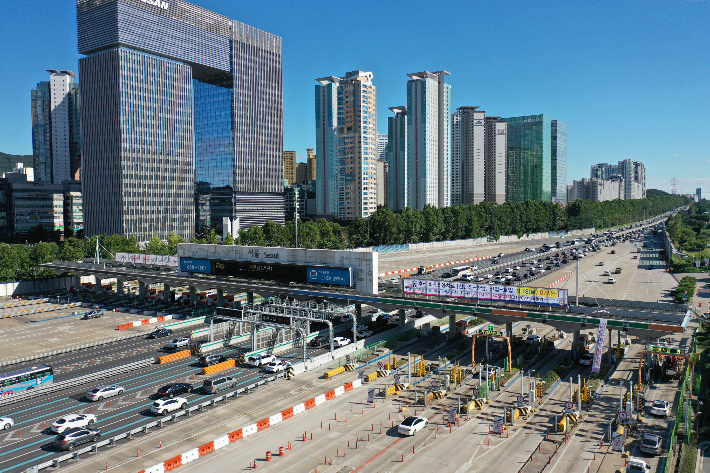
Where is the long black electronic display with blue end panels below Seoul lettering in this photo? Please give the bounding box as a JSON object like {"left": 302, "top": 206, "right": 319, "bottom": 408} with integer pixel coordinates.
{"left": 180, "top": 258, "right": 352, "bottom": 286}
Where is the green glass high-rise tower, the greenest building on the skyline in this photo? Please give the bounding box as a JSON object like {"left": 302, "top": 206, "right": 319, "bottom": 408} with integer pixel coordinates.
{"left": 502, "top": 115, "right": 552, "bottom": 202}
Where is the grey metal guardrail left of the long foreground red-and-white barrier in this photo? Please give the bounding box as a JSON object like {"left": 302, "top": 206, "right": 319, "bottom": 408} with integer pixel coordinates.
{"left": 25, "top": 373, "right": 285, "bottom": 473}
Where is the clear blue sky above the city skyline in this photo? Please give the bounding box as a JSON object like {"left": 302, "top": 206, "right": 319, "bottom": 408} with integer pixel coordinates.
{"left": 0, "top": 0, "right": 710, "bottom": 194}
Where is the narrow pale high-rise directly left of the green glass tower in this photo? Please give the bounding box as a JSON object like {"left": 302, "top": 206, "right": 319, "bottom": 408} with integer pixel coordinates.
{"left": 484, "top": 117, "right": 508, "bottom": 204}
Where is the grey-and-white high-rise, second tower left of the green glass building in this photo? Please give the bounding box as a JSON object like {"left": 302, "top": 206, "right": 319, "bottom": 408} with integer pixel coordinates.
{"left": 450, "top": 107, "right": 486, "bottom": 205}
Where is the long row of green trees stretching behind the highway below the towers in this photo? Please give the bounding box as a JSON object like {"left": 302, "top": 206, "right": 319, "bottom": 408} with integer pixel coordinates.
{"left": 0, "top": 190, "right": 688, "bottom": 282}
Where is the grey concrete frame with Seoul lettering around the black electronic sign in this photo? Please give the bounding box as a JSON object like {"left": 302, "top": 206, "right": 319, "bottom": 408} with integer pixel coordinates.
{"left": 178, "top": 243, "right": 378, "bottom": 294}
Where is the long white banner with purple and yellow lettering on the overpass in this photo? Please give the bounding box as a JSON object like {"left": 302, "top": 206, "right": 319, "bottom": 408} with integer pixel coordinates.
{"left": 404, "top": 279, "right": 567, "bottom": 307}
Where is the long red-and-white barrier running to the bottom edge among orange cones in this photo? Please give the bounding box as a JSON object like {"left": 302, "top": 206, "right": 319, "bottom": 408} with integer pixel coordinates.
{"left": 140, "top": 379, "right": 362, "bottom": 473}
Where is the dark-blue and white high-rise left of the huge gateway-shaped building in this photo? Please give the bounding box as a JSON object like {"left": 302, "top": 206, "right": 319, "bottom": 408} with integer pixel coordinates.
{"left": 31, "top": 69, "right": 81, "bottom": 184}
